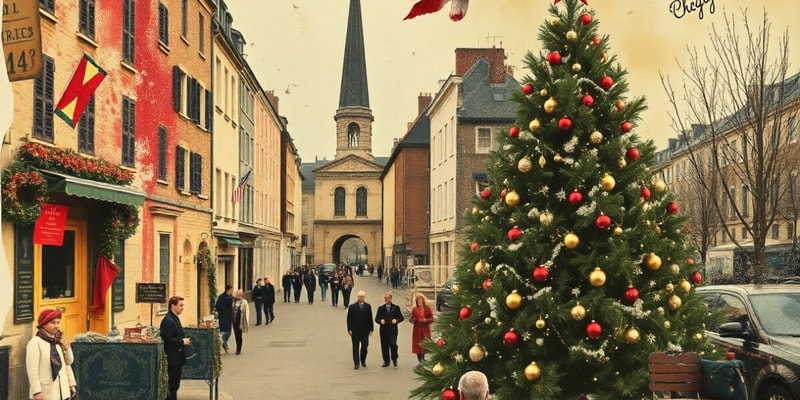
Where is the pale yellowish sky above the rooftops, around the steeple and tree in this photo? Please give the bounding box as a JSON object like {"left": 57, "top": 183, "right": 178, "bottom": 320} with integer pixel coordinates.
{"left": 226, "top": 0, "right": 800, "bottom": 161}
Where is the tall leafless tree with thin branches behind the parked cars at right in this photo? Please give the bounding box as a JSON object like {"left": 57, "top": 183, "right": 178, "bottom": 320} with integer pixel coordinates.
{"left": 661, "top": 9, "right": 800, "bottom": 283}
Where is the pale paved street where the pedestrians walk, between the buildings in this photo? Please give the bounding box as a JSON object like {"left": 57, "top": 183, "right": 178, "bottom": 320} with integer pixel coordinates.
{"left": 178, "top": 275, "right": 418, "bottom": 400}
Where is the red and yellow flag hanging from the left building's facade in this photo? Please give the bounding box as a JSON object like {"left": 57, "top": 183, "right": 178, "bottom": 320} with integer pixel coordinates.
{"left": 53, "top": 54, "right": 107, "bottom": 128}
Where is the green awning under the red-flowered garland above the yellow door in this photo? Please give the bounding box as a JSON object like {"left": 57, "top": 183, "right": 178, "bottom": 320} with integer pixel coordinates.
{"left": 42, "top": 171, "right": 144, "bottom": 207}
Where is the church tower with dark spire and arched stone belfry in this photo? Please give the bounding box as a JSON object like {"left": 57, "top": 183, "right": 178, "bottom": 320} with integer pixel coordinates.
{"left": 333, "top": 0, "right": 375, "bottom": 161}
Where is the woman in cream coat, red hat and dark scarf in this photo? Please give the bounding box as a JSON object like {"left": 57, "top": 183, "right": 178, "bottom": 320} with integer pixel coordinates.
{"left": 25, "top": 309, "right": 77, "bottom": 400}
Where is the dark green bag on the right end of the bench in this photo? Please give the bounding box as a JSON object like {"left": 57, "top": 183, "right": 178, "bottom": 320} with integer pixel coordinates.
{"left": 700, "top": 359, "right": 747, "bottom": 400}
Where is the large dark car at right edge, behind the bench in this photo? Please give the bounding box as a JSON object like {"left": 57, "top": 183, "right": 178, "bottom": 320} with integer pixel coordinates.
{"left": 697, "top": 284, "right": 800, "bottom": 400}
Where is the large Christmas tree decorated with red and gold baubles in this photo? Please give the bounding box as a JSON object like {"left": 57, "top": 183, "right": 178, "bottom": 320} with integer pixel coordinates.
{"left": 412, "top": 0, "right": 713, "bottom": 400}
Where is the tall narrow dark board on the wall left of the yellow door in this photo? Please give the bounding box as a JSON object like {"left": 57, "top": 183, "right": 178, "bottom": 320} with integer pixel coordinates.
{"left": 14, "top": 225, "right": 33, "bottom": 324}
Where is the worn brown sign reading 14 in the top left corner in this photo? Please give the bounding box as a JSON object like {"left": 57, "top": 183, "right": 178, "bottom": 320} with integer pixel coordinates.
{"left": 2, "top": 0, "right": 42, "bottom": 82}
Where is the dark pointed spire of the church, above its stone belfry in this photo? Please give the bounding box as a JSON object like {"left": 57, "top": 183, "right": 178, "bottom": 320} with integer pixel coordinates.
{"left": 339, "top": 0, "right": 369, "bottom": 108}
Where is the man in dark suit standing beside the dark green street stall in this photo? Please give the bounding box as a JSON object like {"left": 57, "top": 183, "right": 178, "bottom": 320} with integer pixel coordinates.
{"left": 160, "top": 296, "right": 191, "bottom": 400}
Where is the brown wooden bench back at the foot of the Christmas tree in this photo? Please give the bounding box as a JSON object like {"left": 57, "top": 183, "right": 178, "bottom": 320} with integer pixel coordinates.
{"left": 649, "top": 353, "right": 710, "bottom": 400}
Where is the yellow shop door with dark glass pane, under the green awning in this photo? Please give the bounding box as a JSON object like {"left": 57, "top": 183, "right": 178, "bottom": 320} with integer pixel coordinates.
{"left": 34, "top": 219, "right": 88, "bottom": 340}
